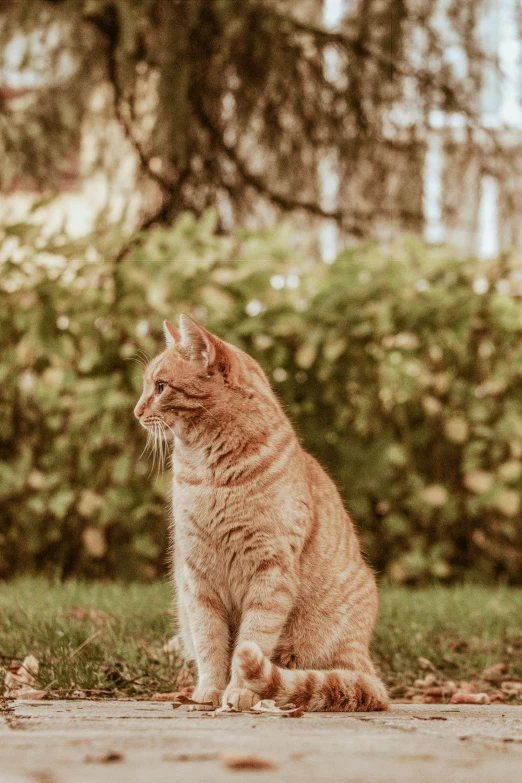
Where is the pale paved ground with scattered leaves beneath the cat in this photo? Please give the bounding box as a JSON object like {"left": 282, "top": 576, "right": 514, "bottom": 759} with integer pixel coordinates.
{"left": 0, "top": 701, "right": 522, "bottom": 783}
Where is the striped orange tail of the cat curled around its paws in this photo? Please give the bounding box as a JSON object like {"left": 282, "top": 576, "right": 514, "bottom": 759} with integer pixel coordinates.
{"left": 234, "top": 642, "right": 388, "bottom": 712}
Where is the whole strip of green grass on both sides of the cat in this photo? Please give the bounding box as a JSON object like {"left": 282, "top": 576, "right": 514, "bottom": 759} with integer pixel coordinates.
{"left": 0, "top": 578, "right": 522, "bottom": 696}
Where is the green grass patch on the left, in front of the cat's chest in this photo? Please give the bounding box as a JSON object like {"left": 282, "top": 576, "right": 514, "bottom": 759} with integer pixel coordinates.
{"left": 0, "top": 578, "right": 181, "bottom": 696}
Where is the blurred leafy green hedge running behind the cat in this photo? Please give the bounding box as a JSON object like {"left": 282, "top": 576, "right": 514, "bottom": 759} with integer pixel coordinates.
{"left": 0, "top": 214, "right": 522, "bottom": 582}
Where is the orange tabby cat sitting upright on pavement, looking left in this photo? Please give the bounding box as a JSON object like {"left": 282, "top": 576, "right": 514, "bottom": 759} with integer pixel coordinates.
{"left": 135, "top": 315, "right": 387, "bottom": 711}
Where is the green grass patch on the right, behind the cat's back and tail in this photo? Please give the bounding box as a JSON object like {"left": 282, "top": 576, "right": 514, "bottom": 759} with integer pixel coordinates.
{"left": 372, "top": 584, "right": 522, "bottom": 686}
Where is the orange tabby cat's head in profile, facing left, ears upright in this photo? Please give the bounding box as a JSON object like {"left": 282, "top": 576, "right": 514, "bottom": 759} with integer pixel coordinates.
{"left": 134, "top": 315, "right": 281, "bottom": 438}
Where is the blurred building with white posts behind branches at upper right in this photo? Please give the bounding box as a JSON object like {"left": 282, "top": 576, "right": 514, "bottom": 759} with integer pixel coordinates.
{"left": 319, "top": 0, "right": 522, "bottom": 262}
